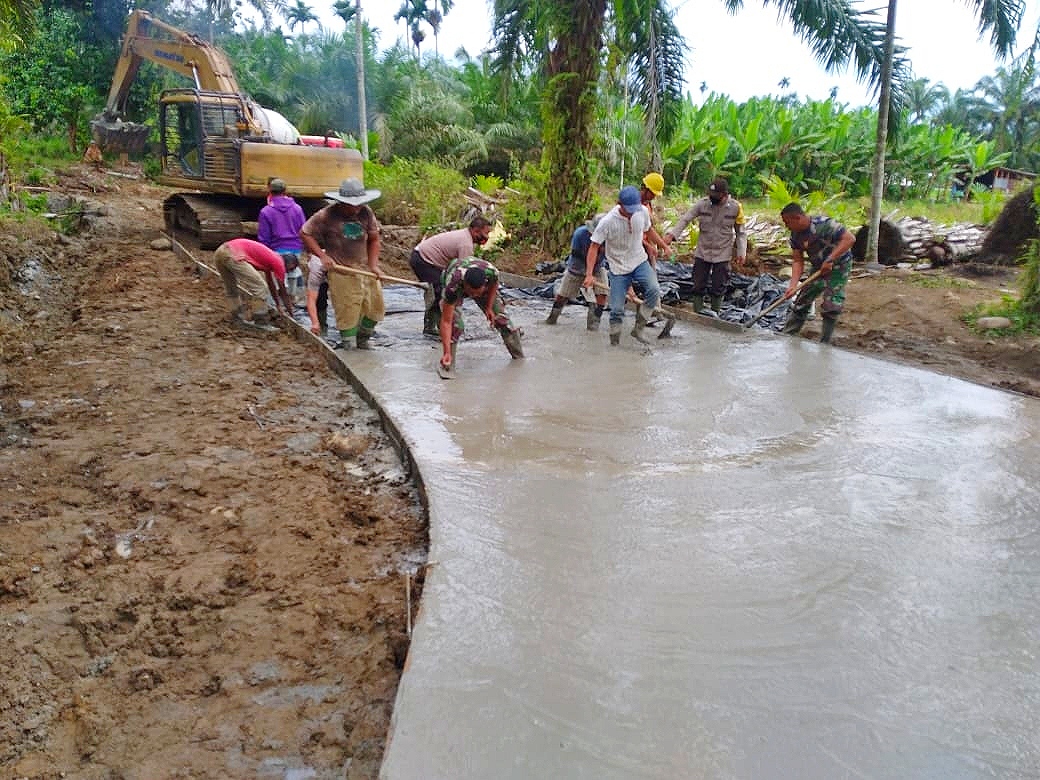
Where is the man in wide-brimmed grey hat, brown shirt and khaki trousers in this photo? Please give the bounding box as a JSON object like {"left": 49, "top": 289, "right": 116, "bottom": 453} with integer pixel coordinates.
{"left": 300, "top": 179, "right": 386, "bottom": 349}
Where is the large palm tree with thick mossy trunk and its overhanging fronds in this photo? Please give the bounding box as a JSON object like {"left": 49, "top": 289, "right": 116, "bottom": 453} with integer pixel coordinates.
{"left": 494, "top": 0, "right": 883, "bottom": 248}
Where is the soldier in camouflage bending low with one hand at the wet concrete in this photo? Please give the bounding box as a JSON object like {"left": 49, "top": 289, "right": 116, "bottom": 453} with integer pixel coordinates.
{"left": 439, "top": 257, "right": 523, "bottom": 376}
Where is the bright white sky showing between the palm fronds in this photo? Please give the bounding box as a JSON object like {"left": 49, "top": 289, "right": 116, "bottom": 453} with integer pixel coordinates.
{"left": 349, "top": 0, "right": 1040, "bottom": 106}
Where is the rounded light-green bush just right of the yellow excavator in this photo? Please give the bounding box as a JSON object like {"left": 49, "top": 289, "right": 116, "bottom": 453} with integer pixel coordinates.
{"left": 365, "top": 158, "right": 467, "bottom": 231}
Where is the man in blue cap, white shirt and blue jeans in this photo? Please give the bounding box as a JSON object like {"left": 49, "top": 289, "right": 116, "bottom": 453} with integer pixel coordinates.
{"left": 582, "top": 186, "right": 672, "bottom": 346}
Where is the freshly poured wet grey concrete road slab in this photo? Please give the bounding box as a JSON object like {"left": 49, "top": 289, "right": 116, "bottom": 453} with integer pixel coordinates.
{"left": 345, "top": 293, "right": 1040, "bottom": 780}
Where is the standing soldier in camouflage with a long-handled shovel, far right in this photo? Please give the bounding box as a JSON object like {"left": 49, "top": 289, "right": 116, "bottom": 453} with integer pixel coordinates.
{"left": 780, "top": 203, "right": 856, "bottom": 343}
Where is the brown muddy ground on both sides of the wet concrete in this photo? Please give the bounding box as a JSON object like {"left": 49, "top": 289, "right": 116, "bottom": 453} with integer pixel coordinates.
{"left": 0, "top": 167, "right": 1040, "bottom": 778}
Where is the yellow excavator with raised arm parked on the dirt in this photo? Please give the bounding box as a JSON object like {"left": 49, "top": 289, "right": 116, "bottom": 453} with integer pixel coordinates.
{"left": 90, "top": 10, "right": 364, "bottom": 249}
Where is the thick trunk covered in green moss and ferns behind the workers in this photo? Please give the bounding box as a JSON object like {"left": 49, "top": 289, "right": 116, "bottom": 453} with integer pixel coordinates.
{"left": 541, "top": 0, "right": 606, "bottom": 248}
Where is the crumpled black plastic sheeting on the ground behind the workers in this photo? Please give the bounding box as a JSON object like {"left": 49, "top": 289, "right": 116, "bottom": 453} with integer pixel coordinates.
{"left": 502, "top": 261, "right": 790, "bottom": 331}
